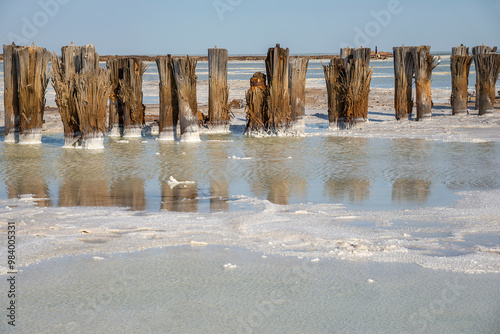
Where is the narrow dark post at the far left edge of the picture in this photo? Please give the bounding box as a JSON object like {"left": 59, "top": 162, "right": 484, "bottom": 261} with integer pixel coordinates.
{"left": 3, "top": 43, "right": 19, "bottom": 143}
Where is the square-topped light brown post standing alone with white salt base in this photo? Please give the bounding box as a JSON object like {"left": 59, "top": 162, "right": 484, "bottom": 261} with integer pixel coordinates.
{"left": 208, "top": 48, "right": 231, "bottom": 133}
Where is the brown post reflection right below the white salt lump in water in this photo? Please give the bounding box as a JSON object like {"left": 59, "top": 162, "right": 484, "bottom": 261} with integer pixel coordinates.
{"left": 161, "top": 182, "right": 198, "bottom": 212}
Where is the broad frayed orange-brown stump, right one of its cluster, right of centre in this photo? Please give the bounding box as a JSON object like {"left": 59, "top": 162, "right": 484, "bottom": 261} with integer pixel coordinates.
{"left": 337, "top": 58, "right": 373, "bottom": 129}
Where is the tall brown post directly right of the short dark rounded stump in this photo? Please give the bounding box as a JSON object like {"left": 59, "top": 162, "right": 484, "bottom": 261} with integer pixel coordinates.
{"left": 266, "top": 44, "right": 291, "bottom": 134}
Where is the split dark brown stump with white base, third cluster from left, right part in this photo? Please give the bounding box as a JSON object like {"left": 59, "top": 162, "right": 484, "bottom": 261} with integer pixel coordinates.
{"left": 117, "top": 58, "right": 146, "bottom": 137}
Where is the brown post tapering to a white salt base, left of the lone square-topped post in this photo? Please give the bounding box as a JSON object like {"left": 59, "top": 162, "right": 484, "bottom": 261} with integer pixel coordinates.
{"left": 172, "top": 56, "right": 200, "bottom": 141}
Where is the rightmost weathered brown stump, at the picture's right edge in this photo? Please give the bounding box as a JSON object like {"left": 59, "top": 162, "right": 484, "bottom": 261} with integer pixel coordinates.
{"left": 474, "top": 53, "right": 500, "bottom": 115}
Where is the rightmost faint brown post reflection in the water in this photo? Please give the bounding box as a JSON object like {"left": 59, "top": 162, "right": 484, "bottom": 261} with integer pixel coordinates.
{"left": 392, "top": 178, "right": 432, "bottom": 204}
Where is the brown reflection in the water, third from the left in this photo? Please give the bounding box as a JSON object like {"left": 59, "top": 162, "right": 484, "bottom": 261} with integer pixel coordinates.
{"left": 110, "top": 176, "right": 146, "bottom": 210}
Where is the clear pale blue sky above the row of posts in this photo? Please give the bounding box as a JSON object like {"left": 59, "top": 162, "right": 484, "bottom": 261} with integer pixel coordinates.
{"left": 0, "top": 0, "right": 500, "bottom": 55}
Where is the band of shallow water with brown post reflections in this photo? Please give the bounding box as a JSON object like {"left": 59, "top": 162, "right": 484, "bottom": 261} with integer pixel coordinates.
{"left": 0, "top": 133, "right": 500, "bottom": 212}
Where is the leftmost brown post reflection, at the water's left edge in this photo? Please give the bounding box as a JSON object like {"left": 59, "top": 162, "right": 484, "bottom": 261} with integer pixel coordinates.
{"left": 3, "top": 146, "right": 52, "bottom": 207}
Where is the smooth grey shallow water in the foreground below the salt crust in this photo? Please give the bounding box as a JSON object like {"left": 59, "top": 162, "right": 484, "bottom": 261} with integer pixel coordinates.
{"left": 7, "top": 246, "right": 500, "bottom": 334}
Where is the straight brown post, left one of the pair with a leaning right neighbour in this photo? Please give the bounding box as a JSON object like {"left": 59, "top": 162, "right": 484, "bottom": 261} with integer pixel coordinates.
{"left": 393, "top": 46, "right": 415, "bottom": 121}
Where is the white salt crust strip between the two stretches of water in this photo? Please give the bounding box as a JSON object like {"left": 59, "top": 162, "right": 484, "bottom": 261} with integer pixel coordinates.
{"left": 0, "top": 190, "right": 500, "bottom": 274}
